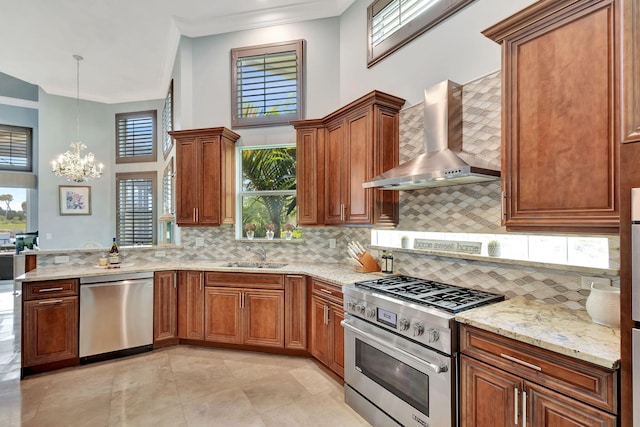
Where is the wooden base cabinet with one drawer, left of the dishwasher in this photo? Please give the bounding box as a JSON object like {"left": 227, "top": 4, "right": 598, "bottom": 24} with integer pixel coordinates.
{"left": 22, "top": 279, "right": 79, "bottom": 373}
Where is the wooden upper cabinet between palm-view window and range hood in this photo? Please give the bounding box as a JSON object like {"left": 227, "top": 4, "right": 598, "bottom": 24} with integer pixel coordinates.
{"left": 292, "top": 91, "right": 404, "bottom": 225}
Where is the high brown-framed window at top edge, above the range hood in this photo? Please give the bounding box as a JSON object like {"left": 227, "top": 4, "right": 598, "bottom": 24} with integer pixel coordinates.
{"left": 367, "top": 0, "right": 474, "bottom": 67}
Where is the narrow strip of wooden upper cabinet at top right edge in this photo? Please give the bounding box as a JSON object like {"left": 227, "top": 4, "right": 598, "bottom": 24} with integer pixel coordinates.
{"left": 620, "top": 0, "right": 640, "bottom": 142}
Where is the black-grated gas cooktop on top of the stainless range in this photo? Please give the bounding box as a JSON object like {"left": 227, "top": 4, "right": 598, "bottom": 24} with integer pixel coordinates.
{"left": 356, "top": 276, "right": 504, "bottom": 313}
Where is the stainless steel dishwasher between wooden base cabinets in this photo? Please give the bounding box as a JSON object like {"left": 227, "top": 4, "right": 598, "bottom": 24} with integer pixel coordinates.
{"left": 80, "top": 273, "right": 153, "bottom": 363}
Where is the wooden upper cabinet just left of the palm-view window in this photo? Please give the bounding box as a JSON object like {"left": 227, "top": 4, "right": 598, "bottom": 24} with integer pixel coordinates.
{"left": 169, "top": 127, "right": 240, "bottom": 226}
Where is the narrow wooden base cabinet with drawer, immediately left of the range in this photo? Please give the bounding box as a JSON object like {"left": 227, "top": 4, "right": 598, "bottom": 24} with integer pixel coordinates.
{"left": 310, "top": 280, "right": 344, "bottom": 378}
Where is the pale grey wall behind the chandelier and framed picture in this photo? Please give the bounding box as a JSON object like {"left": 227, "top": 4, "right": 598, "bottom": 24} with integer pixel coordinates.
{"left": 38, "top": 90, "right": 163, "bottom": 249}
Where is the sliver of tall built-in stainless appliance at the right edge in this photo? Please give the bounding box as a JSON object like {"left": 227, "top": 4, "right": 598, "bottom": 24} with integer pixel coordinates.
{"left": 631, "top": 188, "right": 640, "bottom": 426}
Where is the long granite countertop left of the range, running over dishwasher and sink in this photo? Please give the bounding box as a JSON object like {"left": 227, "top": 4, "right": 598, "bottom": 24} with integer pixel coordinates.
{"left": 16, "top": 260, "right": 382, "bottom": 286}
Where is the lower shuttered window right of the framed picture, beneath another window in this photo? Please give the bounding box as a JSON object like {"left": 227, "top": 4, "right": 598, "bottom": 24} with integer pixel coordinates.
{"left": 116, "top": 172, "right": 156, "bottom": 246}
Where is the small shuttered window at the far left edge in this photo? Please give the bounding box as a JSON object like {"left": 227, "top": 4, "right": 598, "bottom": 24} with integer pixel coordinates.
{"left": 0, "top": 125, "right": 32, "bottom": 172}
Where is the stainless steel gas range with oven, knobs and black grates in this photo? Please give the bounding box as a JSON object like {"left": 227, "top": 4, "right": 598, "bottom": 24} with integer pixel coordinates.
{"left": 342, "top": 276, "right": 504, "bottom": 427}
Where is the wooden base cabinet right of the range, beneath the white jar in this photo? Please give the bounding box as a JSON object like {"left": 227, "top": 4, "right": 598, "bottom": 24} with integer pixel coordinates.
{"left": 460, "top": 325, "right": 618, "bottom": 427}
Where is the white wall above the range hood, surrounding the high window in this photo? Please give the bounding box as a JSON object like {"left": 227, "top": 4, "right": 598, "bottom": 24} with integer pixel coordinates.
{"left": 340, "top": 0, "right": 534, "bottom": 107}
